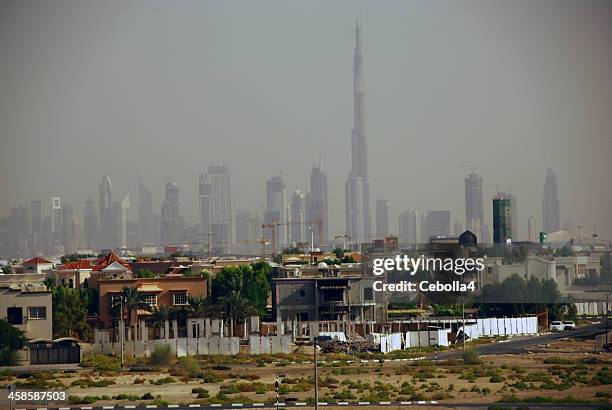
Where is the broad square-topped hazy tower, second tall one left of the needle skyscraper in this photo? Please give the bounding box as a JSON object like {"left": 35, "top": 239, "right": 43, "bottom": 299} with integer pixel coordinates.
{"left": 264, "top": 176, "right": 289, "bottom": 248}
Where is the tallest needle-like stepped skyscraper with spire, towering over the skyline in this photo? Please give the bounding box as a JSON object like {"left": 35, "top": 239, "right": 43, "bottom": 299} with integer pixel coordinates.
{"left": 345, "top": 21, "right": 370, "bottom": 241}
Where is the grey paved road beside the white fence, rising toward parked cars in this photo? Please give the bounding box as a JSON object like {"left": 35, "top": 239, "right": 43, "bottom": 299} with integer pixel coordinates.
{"left": 438, "top": 321, "right": 605, "bottom": 360}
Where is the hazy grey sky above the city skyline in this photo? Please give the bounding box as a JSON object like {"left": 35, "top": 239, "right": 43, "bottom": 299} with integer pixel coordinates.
{"left": 0, "top": 0, "right": 612, "bottom": 238}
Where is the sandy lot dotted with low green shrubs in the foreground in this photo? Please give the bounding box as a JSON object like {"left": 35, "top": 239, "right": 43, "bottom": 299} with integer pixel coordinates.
{"left": 0, "top": 339, "right": 612, "bottom": 409}
